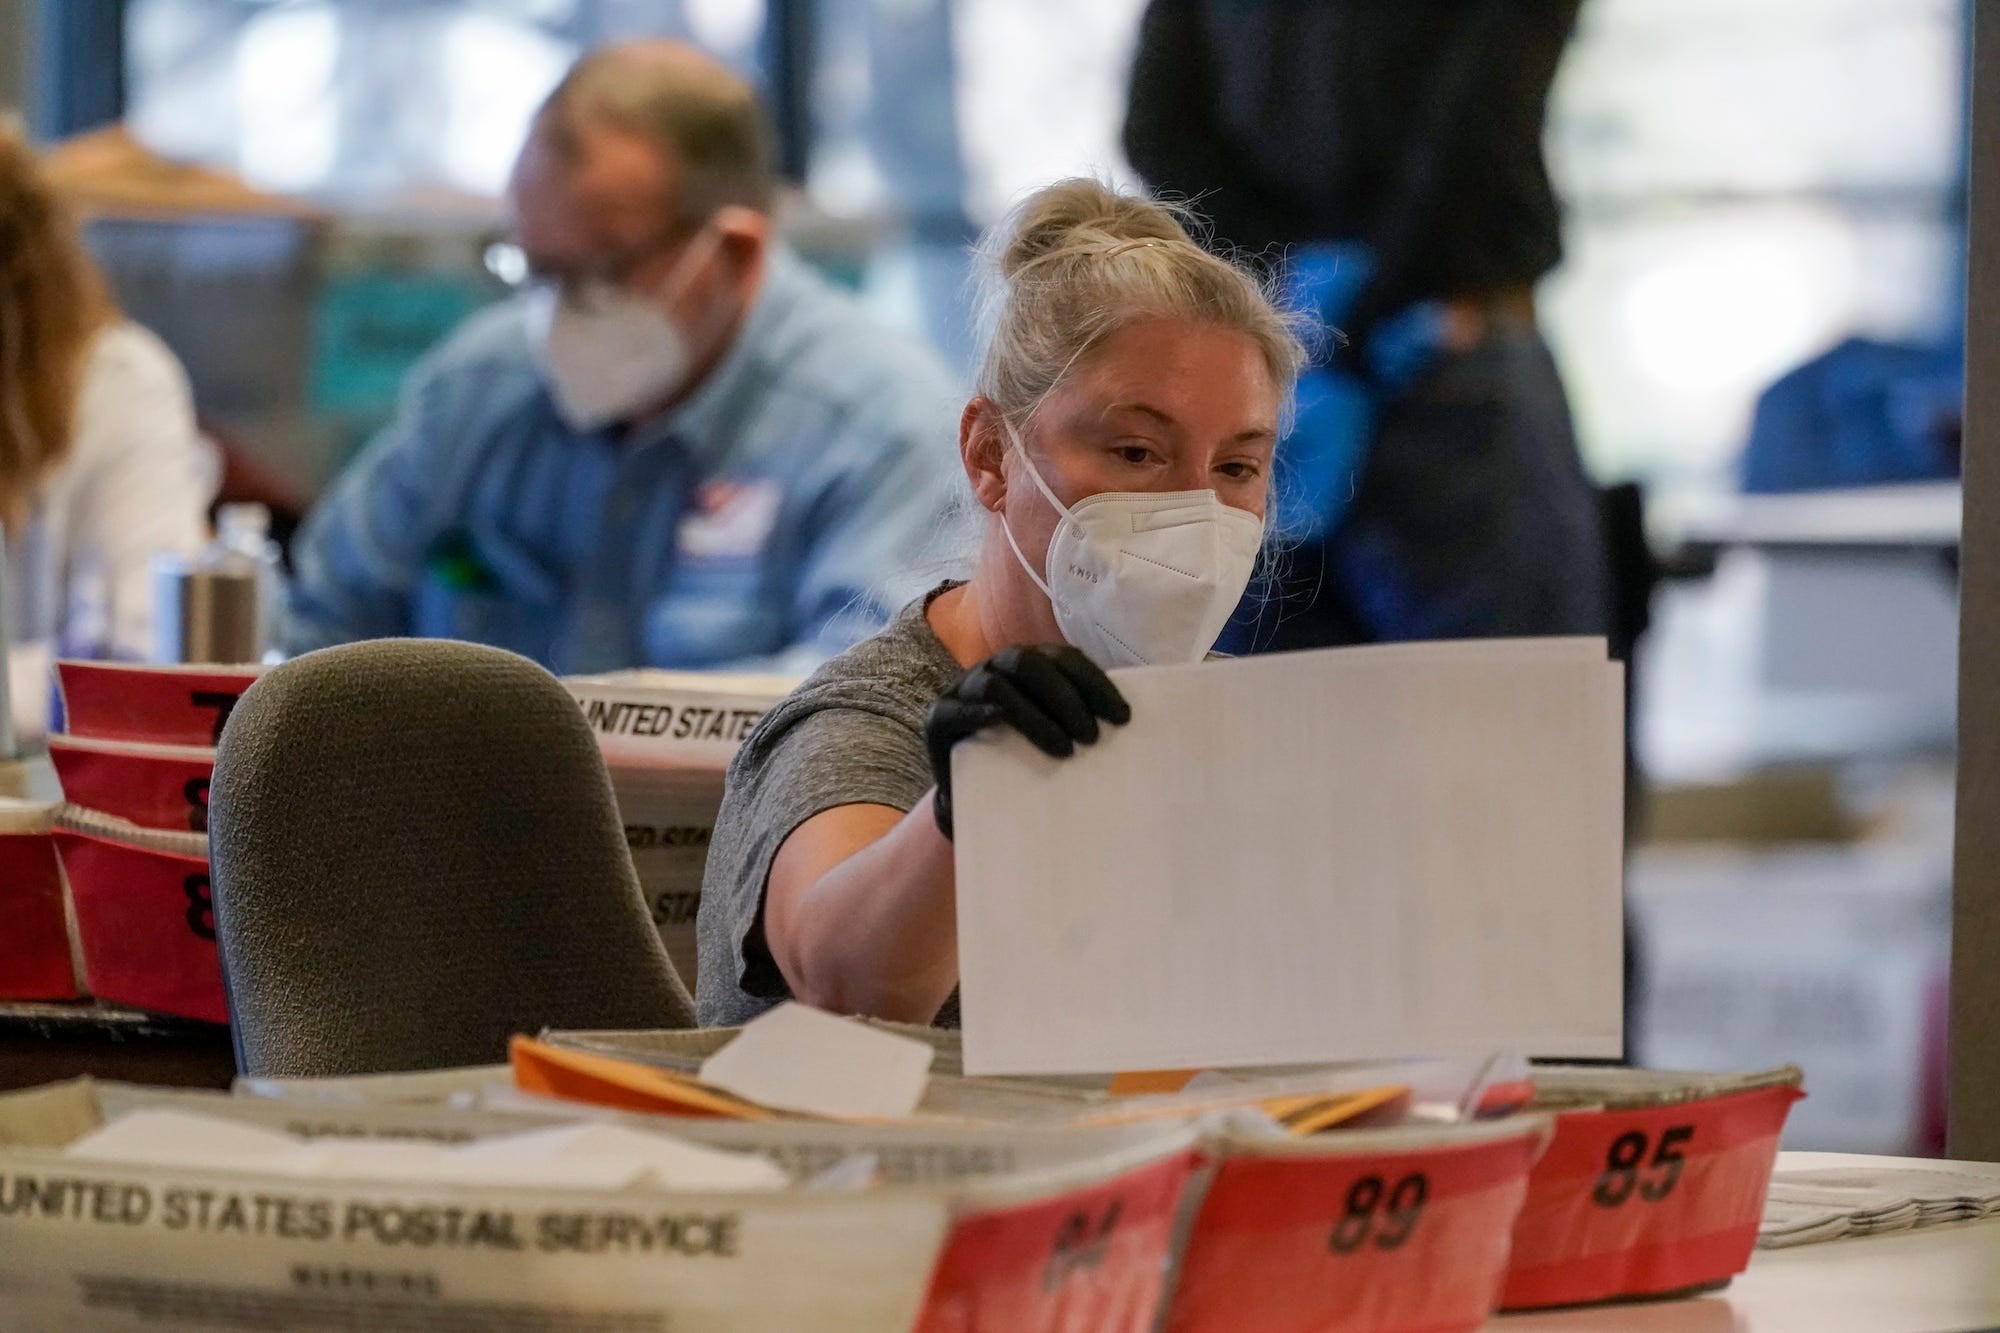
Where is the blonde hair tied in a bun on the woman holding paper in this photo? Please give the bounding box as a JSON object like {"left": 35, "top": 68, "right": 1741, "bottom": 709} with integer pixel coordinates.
{"left": 974, "top": 178, "right": 1306, "bottom": 426}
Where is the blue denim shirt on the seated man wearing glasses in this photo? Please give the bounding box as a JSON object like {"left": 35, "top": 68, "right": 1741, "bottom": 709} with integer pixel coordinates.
{"left": 282, "top": 252, "right": 964, "bottom": 675}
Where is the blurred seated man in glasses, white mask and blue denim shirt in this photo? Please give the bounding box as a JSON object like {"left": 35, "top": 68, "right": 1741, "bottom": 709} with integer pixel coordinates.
{"left": 284, "top": 42, "right": 962, "bottom": 675}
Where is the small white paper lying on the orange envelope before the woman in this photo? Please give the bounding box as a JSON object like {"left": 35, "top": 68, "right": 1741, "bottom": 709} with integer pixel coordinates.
{"left": 702, "top": 1005, "right": 932, "bottom": 1119}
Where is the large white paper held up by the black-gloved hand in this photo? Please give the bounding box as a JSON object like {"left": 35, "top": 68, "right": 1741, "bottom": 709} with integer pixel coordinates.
{"left": 952, "top": 638, "right": 1624, "bottom": 1075}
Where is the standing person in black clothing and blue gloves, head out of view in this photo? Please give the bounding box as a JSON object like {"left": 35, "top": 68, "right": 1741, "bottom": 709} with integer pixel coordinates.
{"left": 1124, "top": 0, "right": 1610, "bottom": 650}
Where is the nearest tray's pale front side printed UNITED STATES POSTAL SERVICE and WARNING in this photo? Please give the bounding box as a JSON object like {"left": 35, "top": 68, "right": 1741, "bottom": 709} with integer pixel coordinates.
{"left": 0, "top": 1144, "right": 946, "bottom": 1333}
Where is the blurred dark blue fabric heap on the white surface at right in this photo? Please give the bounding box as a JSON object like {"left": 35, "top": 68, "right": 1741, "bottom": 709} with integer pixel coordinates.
{"left": 1742, "top": 338, "right": 1966, "bottom": 492}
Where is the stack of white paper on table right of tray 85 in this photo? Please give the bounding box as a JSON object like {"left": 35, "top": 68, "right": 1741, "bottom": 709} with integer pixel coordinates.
{"left": 1758, "top": 1153, "right": 2000, "bottom": 1249}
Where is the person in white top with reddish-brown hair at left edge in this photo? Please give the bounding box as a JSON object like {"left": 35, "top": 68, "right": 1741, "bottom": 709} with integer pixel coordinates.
{"left": 0, "top": 122, "right": 218, "bottom": 733}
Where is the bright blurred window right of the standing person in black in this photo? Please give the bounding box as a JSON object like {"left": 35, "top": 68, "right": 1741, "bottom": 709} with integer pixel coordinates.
{"left": 1542, "top": 0, "right": 1964, "bottom": 484}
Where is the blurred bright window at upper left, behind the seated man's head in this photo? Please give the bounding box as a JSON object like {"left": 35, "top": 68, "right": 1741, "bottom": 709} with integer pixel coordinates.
{"left": 126, "top": 0, "right": 766, "bottom": 208}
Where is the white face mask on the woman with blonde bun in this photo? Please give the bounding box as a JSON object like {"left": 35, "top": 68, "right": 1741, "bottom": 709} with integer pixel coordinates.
{"left": 1000, "top": 430, "right": 1264, "bottom": 669}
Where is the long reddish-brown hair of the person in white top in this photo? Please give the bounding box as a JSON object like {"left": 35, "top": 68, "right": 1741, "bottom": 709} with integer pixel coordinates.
{"left": 0, "top": 120, "right": 118, "bottom": 538}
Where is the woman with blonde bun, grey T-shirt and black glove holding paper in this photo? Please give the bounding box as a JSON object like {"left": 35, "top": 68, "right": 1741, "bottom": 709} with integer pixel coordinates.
{"left": 698, "top": 180, "right": 1302, "bottom": 1025}
